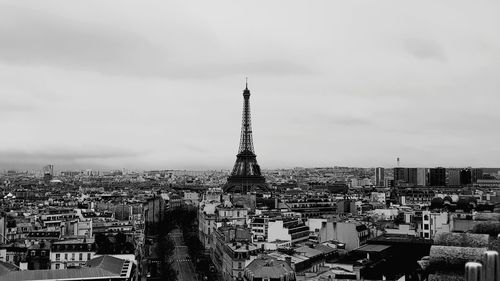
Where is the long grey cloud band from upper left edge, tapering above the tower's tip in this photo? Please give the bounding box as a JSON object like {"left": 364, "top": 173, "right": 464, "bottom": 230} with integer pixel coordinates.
{"left": 0, "top": 6, "right": 311, "bottom": 79}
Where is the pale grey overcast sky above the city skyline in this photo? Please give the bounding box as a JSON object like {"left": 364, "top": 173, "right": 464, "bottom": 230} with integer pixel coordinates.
{"left": 0, "top": 0, "right": 500, "bottom": 170}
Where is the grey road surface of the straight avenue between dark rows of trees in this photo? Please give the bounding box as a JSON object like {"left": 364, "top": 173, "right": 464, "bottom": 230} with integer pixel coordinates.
{"left": 169, "top": 229, "right": 198, "bottom": 281}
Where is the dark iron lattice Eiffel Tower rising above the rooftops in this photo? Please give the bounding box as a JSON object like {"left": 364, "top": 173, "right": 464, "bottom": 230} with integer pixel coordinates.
{"left": 224, "top": 84, "right": 269, "bottom": 193}
